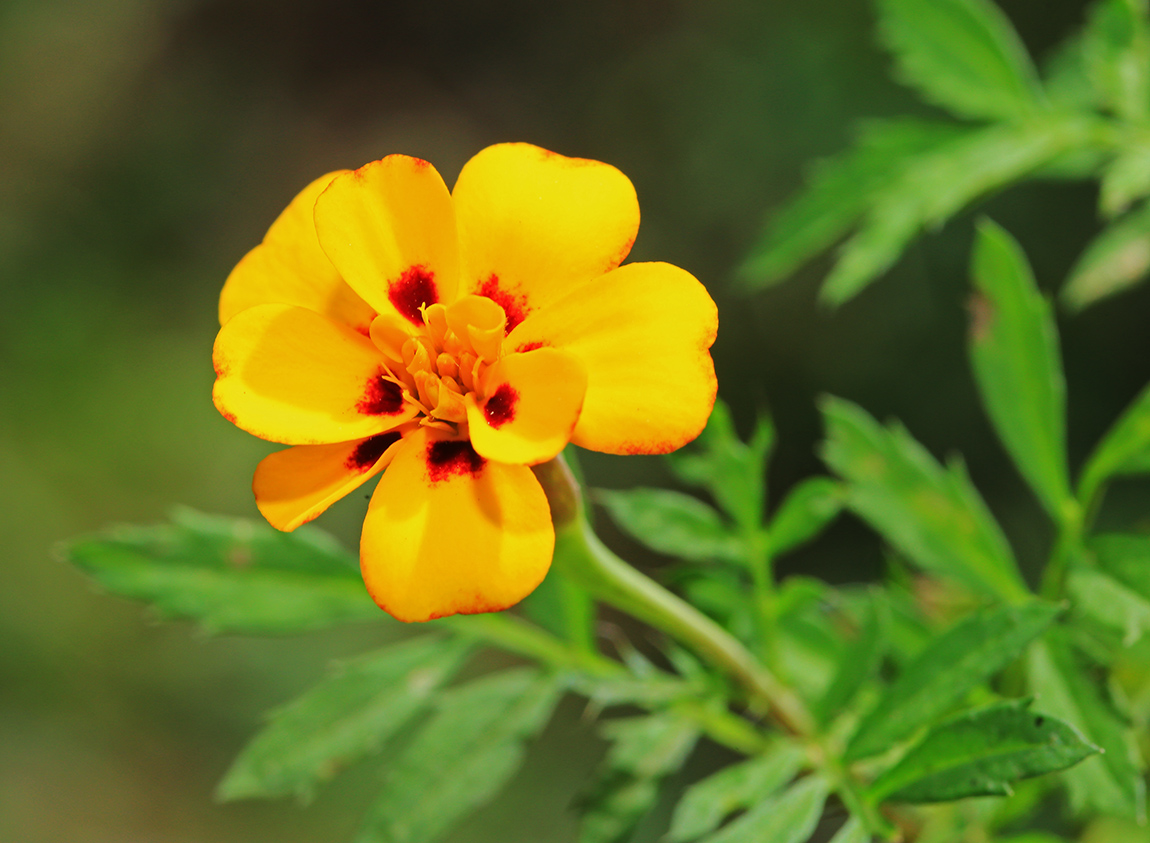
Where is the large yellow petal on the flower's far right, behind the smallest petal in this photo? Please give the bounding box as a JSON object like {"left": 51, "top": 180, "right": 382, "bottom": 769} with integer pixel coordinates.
{"left": 506, "top": 263, "right": 719, "bottom": 454}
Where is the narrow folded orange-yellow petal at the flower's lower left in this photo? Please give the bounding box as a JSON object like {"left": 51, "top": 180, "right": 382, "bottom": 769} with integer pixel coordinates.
{"left": 252, "top": 431, "right": 399, "bottom": 531}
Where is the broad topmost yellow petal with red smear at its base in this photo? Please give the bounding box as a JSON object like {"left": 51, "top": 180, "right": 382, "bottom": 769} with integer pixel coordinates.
{"left": 452, "top": 144, "right": 639, "bottom": 330}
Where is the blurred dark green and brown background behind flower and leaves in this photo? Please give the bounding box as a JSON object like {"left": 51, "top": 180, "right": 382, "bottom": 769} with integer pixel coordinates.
{"left": 0, "top": 0, "right": 1150, "bottom": 843}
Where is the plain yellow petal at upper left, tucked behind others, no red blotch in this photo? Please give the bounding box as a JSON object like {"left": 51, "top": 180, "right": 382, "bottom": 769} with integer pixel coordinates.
{"left": 220, "top": 170, "right": 375, "bottom": 331}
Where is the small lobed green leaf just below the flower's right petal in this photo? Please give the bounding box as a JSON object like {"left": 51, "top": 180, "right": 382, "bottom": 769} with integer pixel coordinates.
{"left": 667, "top": 400, "right": 775, "bottom": 529}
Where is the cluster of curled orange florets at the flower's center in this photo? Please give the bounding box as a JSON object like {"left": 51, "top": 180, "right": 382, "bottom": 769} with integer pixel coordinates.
{"left": 371, "top": 296, "right": 507, "bottom": 432}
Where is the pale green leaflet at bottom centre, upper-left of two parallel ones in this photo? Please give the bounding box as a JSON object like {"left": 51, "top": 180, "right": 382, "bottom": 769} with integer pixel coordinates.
{"left": 667, "top": 741, "right": 804, "bottom": 843}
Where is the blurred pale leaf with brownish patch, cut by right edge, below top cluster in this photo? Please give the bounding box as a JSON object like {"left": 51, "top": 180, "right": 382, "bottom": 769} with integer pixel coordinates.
{"left": 1059, "top": 204, "right": 1150, "bottom": 311}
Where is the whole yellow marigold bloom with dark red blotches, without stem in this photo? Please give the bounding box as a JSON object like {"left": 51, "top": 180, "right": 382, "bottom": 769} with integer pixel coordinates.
{"left": 213, "top": 144, "right": 718, "bottom": 621}
